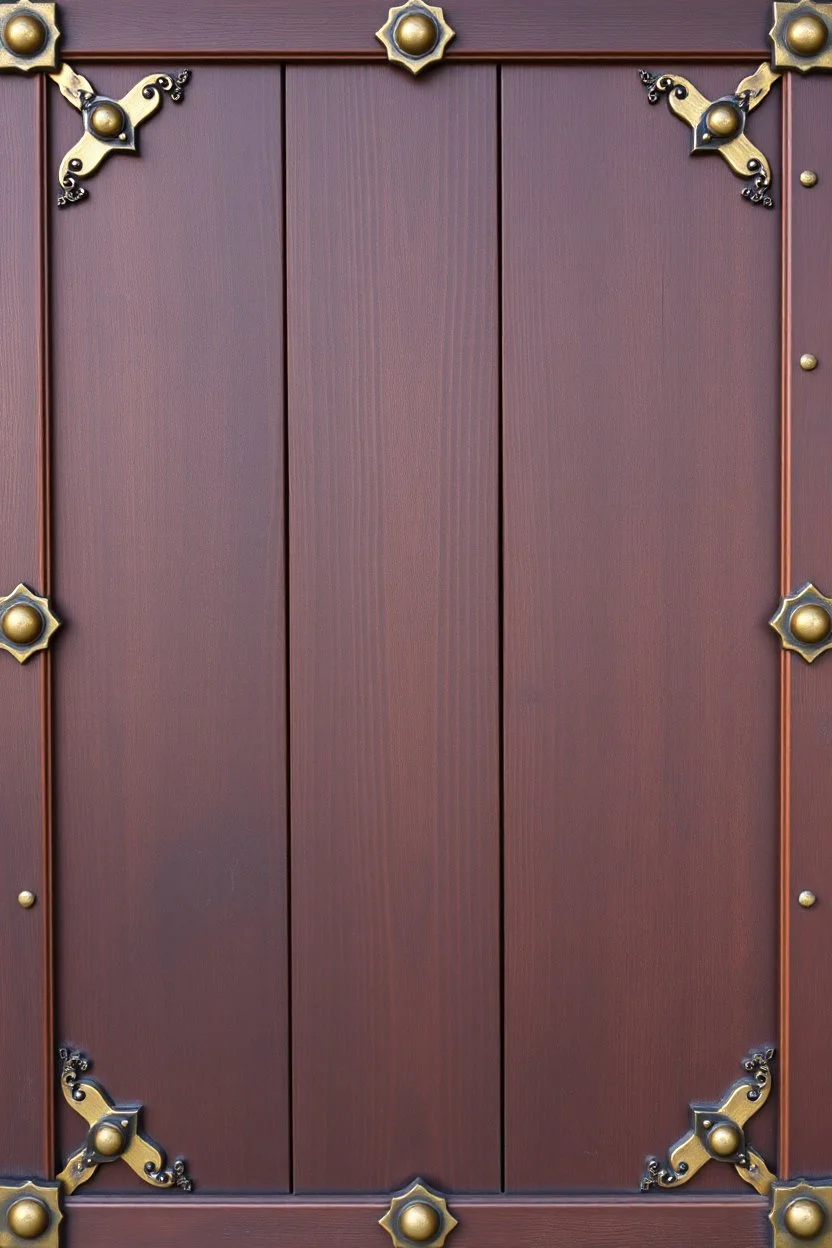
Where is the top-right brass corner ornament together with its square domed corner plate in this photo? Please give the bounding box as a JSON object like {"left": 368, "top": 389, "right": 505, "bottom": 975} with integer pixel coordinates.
{"left": 640, "top": 0, "right": 832, "bottom": 208}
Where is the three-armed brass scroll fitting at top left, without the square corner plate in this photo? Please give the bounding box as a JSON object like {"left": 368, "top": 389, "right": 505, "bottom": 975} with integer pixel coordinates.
{"left": 50, "top": 65, "right": 191, "bottom": 208}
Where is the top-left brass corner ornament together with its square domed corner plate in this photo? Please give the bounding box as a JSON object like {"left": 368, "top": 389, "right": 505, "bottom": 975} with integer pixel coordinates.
{"left": 0, "top": 0, "right": 191, "bottom": 208}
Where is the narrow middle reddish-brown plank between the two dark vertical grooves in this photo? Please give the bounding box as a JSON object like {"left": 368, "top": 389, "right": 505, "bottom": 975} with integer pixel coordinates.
{"left": 287, "top": 67, "right": 500, "bottom": 1192}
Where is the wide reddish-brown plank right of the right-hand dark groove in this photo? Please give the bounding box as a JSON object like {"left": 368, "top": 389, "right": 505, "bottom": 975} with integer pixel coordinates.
{"left": 503, "top": 66, "right": 783, "bottom": 1191}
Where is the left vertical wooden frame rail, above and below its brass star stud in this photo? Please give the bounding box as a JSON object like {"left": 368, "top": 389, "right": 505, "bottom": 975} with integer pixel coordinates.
{"left": 0, "top": 75, "right": 48, "bottom": 1174}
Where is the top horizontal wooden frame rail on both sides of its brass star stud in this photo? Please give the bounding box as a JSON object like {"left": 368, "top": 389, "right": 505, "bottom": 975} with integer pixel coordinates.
{"left": 61, "top": 0, "right": 771, "bottom": 58}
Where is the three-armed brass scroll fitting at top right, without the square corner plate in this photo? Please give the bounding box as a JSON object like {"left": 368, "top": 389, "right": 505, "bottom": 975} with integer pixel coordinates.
{"left": 639, "top": 62, "right": 780, "bottom": 208}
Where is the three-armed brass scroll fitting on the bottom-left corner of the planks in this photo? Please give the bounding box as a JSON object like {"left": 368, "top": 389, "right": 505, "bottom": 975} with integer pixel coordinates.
{"left": 57, "top": 1047, "right": 193, "bottom": 1193}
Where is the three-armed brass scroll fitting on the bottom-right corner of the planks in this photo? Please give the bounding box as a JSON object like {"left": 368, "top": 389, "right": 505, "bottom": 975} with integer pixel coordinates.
{"left": 641, "top": 1048, "right": 776, "bottom": 1196}
